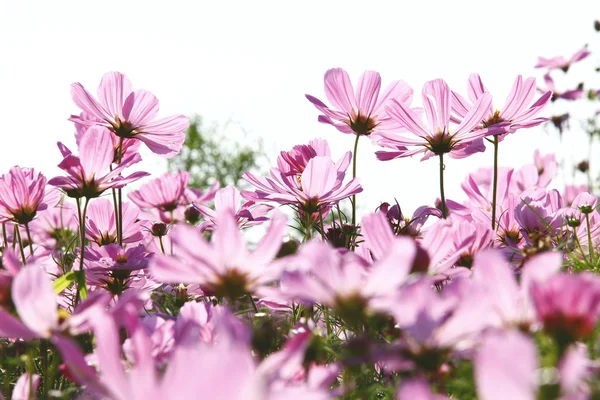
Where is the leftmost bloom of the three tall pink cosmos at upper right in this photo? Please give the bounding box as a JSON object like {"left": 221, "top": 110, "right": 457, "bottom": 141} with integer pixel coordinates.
{"left": 306, "top": 68, "right": 413, "bottom": 135}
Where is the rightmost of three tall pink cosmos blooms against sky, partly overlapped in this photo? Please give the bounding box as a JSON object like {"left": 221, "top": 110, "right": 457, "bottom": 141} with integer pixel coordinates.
{"left": 452, "top": 74, "right": 552, "bottom": 140}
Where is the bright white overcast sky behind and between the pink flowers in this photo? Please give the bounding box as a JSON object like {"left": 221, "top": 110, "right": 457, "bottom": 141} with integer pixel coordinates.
{"left": 0, "top": 0, "right": 600, "bottom": 216}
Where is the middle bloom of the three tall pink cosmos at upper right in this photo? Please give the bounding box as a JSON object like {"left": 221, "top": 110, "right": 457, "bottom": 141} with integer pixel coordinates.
{"left": 376, "top": 79, "right": 492, "bottom": 160}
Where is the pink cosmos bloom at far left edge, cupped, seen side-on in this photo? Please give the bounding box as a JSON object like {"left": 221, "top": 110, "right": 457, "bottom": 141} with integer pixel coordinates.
{"left": 0, "top": 167, "right": 54, "bottom": 224}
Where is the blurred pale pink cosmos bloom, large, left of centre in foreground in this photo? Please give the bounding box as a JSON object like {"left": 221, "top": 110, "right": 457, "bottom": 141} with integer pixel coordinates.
{"left": 150, "top": 210, "right": 286, "bottom": 299}
